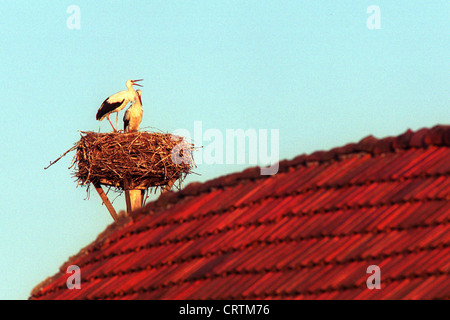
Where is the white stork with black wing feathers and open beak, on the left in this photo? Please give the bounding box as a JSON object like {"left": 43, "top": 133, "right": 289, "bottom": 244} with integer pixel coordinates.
{"left": 96, "top": 79, "right": 144, "bottom": 131}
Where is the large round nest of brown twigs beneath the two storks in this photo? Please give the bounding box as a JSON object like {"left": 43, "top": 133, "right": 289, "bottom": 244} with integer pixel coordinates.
{"left": 72, "top": 131, "right": 195, "bottom": 190}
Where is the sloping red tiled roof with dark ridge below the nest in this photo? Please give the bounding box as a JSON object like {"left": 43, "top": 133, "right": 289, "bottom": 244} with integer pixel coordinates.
{"left": 30, "top": 126, "right": 450, "bottom": 299}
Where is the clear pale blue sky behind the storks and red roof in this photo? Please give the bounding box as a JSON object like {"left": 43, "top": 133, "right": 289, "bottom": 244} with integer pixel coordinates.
{"left": 0, "top": 0, "right": 450, "bottom": 299}
